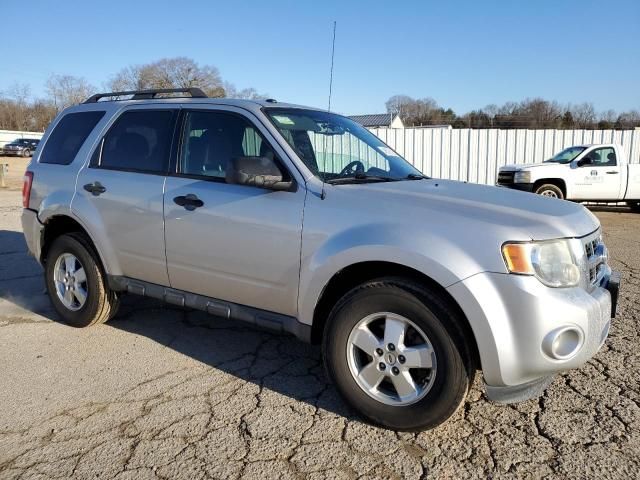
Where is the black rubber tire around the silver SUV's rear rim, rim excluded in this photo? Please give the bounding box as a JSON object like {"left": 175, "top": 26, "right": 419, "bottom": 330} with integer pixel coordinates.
{"left": 45, "top": 233, "right": 120, "bottom": 327}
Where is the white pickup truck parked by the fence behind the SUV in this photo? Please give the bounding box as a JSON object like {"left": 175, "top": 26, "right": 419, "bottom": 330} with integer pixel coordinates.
{"left": 498, "top": 144, "right": 640, "bottom": 210}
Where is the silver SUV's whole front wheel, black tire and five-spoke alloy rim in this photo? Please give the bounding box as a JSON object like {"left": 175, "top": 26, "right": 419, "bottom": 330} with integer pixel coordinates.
{"left": 323, "top": 279, "right": 474, "bottom": 430}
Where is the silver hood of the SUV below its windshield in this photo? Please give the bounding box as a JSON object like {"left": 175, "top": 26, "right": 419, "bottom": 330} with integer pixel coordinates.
{"left": 338, "top": 179, "right": 600, "bottom": 241}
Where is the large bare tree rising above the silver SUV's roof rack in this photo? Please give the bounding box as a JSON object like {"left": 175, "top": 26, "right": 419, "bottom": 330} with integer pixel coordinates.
{"left": 109, "top": 57, "right": 225, "bottom": 97}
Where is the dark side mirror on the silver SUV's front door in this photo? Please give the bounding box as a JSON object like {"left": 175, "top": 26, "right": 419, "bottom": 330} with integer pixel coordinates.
{"left": 226, "top": 157, "right": 293, "bottom": 191}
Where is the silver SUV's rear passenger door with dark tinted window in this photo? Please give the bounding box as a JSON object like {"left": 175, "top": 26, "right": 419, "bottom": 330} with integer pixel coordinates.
{"left": 72, "top": 105, "right": 178, "bottom": 285}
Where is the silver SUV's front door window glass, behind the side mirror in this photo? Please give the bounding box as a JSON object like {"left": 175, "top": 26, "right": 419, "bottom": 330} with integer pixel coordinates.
{"left": 178, "top": 111, "right": 275, "bottom": 179}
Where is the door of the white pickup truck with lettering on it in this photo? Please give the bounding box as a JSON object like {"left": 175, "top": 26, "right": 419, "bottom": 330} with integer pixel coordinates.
{"left": 572, "top": 147, "right": 624, "bottom": 200}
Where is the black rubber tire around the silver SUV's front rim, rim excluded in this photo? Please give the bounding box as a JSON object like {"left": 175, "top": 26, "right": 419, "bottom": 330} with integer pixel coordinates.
{"left": 323, "top": 278, "right": 475, "bottom": 431}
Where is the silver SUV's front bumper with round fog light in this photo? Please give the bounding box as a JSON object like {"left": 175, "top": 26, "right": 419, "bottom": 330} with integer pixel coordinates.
{"left": 448, "top": 267, "right": 619, "bottom": 402}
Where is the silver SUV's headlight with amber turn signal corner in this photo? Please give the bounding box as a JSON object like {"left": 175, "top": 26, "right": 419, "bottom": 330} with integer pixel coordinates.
{"left": 502, "top": 240, "right": 580, "bottom": 287}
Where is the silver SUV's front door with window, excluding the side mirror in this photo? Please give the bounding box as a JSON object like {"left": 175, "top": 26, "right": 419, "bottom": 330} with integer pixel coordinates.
{"left": 164, "top": 107, "right": 306, "bottom": 316}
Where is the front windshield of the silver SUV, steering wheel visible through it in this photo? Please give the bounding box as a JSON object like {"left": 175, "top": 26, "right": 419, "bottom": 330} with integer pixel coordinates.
{"left": 265, "top": 108, "right": 423, "bottom": 183}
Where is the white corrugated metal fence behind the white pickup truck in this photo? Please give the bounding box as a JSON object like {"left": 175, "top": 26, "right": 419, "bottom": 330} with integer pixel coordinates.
{"left": 371, "top": 128, "right": 640, "bottom": 185}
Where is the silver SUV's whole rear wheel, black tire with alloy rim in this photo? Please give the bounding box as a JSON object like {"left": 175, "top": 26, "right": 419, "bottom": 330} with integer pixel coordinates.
{"left": 45, "top": 233, "right": 119, "bottom": 327}
